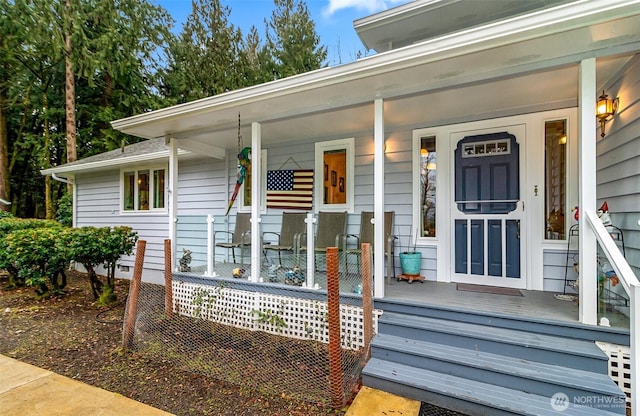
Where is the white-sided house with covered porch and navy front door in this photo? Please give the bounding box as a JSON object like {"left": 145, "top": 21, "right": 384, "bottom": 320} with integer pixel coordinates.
{"left": 43, "top": 0, "right": 640, "bottom": 412}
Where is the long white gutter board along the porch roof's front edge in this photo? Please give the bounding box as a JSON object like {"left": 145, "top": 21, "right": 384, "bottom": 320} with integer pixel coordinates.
{"left": 111, "top": 0, "right": 640, "bottom": 138}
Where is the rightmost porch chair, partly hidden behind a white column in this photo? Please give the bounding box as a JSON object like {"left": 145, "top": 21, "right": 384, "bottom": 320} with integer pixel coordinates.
{"left": 345, "top": 211, "right": 398, "bottom": 279}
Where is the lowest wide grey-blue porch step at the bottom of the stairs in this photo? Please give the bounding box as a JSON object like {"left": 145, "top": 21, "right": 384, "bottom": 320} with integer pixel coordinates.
{"left": 363, "top": 358, "right": 624, "bottom": 416}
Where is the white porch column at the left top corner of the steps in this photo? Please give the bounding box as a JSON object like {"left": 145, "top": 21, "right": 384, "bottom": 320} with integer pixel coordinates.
{"left": 373, "top": 98, "right": 386, "bottom": 298}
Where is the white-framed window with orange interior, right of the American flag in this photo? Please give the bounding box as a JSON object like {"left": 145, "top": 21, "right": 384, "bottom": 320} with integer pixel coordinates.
{"left": 314, "top": 137, "right": 355, "bottom": 212}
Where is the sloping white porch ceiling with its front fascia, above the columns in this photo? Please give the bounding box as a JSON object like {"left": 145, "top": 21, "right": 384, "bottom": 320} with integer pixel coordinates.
{"left": 113, "top": 2, "right": 640, "bottom": 153}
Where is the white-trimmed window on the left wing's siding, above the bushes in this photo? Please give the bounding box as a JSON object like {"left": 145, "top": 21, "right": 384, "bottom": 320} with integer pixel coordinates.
{"left": 120, "top": 167, "right": 167, "bottom": 212}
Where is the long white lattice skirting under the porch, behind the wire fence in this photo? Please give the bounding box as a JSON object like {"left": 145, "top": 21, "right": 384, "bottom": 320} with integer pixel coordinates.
{"left": 173, "top": 281, "right": 382, "bottom": 350}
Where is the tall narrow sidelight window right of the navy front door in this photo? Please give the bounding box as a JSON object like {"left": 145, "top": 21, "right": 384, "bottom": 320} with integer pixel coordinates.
{"left": 544, "top": 119, "right": 567, "bottom": 240}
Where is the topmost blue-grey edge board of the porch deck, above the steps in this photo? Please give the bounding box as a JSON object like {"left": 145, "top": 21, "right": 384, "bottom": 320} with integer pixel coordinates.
{"left": 375, "top": 299, "right": 630, "bottom": 345}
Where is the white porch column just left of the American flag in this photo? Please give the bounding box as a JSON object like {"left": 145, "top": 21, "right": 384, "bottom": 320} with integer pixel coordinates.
{"left": 250, "top": 122, "right": 262, "bottom": 282}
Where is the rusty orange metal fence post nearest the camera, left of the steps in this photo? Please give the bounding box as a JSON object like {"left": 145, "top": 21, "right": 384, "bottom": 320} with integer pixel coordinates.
{"left": 327, "top": 247, "right": 344, "bottom": 408}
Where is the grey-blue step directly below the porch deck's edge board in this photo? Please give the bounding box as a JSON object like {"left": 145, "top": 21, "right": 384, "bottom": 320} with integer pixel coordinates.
{"left": 378, "top": 312, "right": 608, "bottom": 374}
